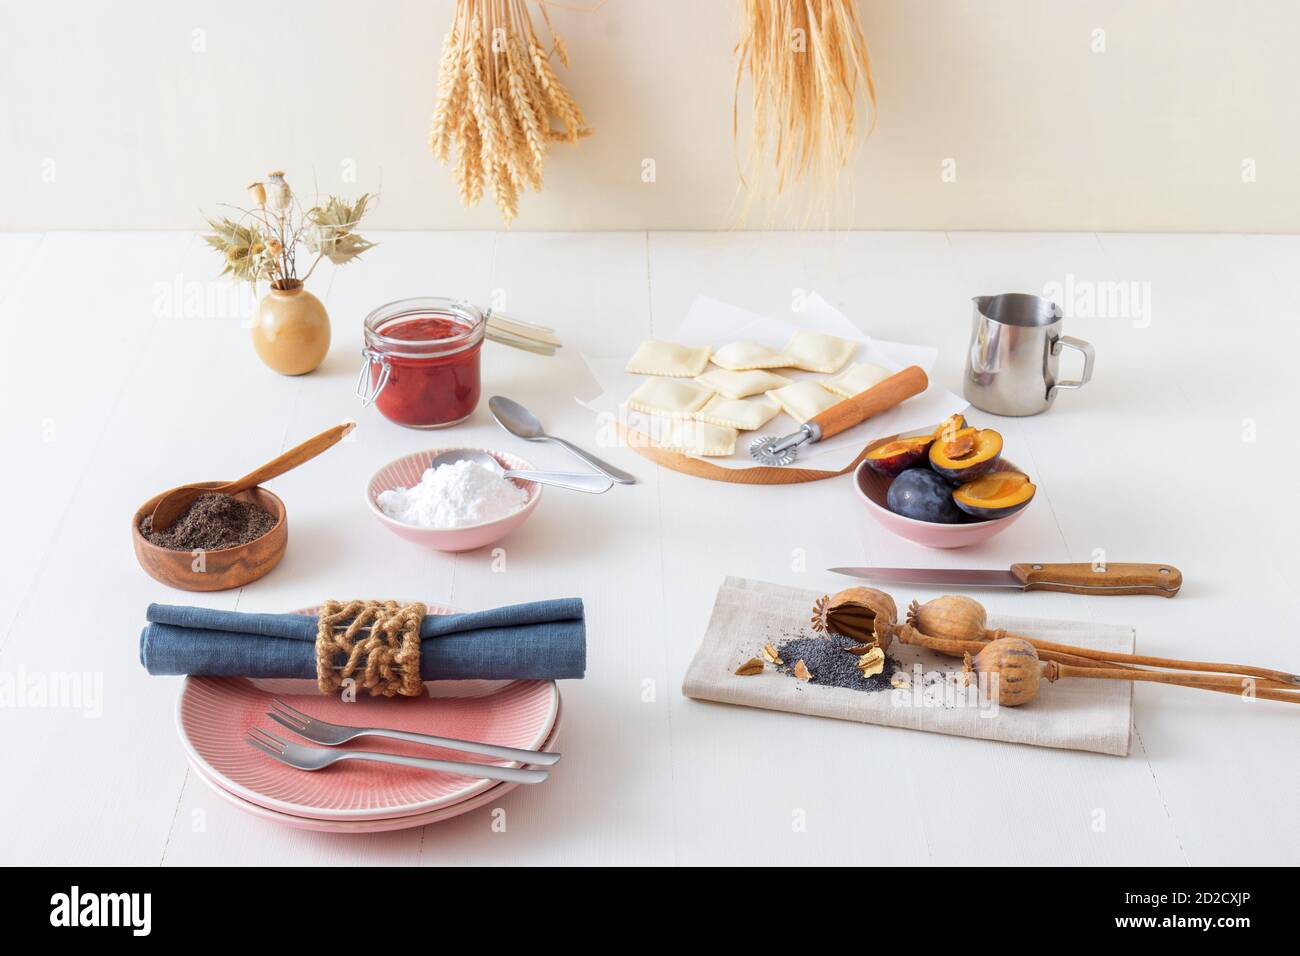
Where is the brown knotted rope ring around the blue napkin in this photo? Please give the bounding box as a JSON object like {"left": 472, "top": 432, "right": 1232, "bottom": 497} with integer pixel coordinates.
{"left": 316, "top": 601, "right": 428, "bottom": 697}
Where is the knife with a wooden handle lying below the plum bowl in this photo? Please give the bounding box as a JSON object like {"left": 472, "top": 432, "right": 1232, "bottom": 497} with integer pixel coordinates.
{"left": 828, "top": 564, "right": 1183, "bottom": 597}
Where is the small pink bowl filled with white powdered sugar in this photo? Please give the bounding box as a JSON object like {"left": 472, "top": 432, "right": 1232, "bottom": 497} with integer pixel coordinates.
{"left": 365, "top": 449, "right": 542, "bottom": 551}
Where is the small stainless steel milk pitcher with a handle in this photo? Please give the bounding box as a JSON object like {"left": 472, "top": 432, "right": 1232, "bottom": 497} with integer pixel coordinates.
{"left": 962, "top": 293, "right": 1093, "bottom": 415}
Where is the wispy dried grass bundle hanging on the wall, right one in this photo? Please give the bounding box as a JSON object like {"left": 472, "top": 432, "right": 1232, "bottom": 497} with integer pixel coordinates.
{"left": 732, "top": 0, "right": 876, "bottom": 213}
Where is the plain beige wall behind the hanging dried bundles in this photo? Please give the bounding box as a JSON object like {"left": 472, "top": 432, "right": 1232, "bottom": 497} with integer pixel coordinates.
{"left": 0, "top": 0, "right": 1300, "bottom": 233}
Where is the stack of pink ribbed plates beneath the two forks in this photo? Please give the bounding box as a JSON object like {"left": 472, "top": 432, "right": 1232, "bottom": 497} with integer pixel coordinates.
{"left": 176, "top": 605, "right": 560, "bottom": 832}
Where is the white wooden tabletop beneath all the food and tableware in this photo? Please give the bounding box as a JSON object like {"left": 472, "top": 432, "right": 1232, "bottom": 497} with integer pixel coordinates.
{"left": 0, "top": 233, "right": 1300, "bottom": 865}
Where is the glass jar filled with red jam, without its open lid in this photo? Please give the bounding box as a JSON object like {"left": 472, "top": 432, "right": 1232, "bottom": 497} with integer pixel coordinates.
{"left": 356, "top": 297, "right": 488, "bottom": 428}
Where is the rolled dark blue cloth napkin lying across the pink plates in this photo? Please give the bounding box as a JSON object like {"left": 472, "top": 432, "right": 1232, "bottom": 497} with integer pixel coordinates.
{"left": 140, "top": 597, "right": 586, "bottom": 680}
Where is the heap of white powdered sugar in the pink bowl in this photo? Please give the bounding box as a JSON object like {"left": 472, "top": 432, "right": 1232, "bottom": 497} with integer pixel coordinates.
{"left": 374, "top": 460, "right": 528, "bottom": 528}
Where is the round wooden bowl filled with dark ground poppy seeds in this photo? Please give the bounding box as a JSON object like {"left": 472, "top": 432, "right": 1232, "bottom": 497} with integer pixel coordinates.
{"left": 131, "top": 481, "right": 289, "bottom": 591}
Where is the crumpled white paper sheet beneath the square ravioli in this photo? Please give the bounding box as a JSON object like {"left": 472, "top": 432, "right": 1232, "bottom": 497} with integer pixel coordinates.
{"left": 582, "top": 293, "right": 966, "bottom": 471}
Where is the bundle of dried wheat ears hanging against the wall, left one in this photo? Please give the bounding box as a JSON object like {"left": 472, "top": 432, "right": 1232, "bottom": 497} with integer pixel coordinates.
{"left": 429, "top": 0, "right": 592, "bottom": 224}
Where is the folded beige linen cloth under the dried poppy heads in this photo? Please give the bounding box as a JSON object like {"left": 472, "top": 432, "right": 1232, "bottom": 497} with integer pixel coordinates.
{"left": 681, "top": 578, "right": 1135, "bottom": 757}
